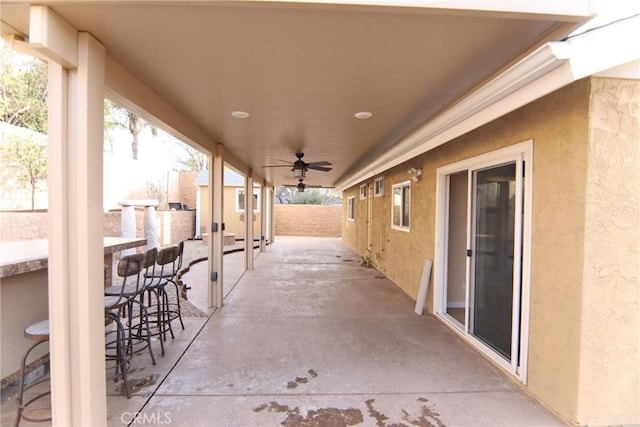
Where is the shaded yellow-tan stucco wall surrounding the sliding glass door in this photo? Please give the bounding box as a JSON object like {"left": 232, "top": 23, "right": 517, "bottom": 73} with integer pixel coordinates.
{"left": 343, "top": 79, "right": 624, "bottom": 423}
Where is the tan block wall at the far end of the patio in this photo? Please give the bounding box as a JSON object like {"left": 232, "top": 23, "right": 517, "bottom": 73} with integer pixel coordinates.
{"left": 275, "top": 205, "right": 342, "bottom": 237}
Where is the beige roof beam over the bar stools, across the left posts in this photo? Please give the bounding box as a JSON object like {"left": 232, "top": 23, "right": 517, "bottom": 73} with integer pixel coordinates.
{"left": 105, "top": 56, "right": 264, "bottom": 186}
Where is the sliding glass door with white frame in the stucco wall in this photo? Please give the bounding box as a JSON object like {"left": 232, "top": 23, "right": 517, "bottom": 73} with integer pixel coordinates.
{"left": 436, "top": 144, "right": 531, "bottom": 377}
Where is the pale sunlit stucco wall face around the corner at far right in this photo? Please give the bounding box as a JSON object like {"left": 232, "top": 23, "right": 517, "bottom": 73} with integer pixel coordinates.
{"left": 577, "top": 79, "right": 640, "bottom": 425}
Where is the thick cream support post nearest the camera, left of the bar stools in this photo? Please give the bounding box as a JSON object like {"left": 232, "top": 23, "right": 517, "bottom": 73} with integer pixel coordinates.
{"left": 46, "top": 28, "right": 107, "bottom": 426}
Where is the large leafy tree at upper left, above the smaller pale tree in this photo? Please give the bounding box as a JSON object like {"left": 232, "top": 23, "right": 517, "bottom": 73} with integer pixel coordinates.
{"left": 0, "top": 48, "right": 47, "bottom": 133}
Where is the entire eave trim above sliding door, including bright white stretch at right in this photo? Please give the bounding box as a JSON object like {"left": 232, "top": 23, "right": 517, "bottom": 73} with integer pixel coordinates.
{"left": 336, "top": 15, "right": 640, "bottom": 191}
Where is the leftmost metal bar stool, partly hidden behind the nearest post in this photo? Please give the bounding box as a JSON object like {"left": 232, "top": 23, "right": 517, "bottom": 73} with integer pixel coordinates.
{"left": 13, "top": 319, "right": 51, "bottom": 427}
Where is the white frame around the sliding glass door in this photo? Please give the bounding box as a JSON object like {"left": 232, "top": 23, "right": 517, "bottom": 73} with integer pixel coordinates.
{"left": 433, "top": 140, "right": 533, "bottom": 384}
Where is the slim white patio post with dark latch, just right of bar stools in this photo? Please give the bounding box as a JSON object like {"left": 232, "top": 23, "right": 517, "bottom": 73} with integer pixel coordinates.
{"left": 206, "top": 144, "right": 224, "bottom": 308}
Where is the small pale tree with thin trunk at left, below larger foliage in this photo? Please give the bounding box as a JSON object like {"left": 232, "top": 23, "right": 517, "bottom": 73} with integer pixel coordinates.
{"left": 0, "top": 135, "right": 47, "bottom": 210}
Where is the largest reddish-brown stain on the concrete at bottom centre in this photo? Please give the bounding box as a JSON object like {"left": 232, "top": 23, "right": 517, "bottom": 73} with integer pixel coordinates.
{"left": 254, "top": 402, "right": 364, "bottom": 427}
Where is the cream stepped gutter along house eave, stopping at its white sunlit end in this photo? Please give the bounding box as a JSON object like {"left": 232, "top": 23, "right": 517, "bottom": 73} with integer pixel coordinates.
{"left": 336, "top": 42, "right": 573, "bottom": 189}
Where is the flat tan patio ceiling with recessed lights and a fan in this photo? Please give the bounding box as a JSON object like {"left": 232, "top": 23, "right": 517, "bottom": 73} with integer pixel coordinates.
{"left": 0, "top": 0, "right": 589, "bottom": 186}
